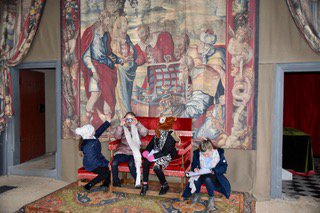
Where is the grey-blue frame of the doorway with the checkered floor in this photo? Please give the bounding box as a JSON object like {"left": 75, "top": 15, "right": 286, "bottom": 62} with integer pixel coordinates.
{"left": 270, "top": 62, "right": 320, "bottom": 198}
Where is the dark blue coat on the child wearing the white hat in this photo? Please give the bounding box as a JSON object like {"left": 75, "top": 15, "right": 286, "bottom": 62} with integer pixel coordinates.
{"left": 81, "top": 121, "right": 110, "bottom": 171}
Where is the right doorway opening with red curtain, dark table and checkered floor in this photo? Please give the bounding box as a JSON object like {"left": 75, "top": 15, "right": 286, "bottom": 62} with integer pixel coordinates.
{"left": 282, "top": 72, "right": 320, "bottom": 198}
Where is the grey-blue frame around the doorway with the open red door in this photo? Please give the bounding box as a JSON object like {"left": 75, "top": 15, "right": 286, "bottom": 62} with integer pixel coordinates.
{"left": 4, "top": 60, "right": 62, "bottom": 180}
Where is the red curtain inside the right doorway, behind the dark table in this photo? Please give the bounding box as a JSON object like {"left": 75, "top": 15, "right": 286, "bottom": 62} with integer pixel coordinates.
{"left": 283, "top": 72, "right": 320, "bottom": 157}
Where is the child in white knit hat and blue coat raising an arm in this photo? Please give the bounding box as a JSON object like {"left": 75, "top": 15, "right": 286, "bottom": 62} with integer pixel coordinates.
{"left": 76, "top": 119, "right": 110, "bottom": 191}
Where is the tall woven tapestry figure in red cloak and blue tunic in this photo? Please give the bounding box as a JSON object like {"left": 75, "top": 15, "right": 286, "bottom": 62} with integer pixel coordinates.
{"left": 81, "top": 10, "right": 123, "bottom": 126}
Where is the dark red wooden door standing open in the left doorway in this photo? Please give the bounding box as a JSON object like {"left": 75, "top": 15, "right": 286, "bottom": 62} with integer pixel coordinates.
{"left": 19, "top": 70, "right": 46, "bottom": 163}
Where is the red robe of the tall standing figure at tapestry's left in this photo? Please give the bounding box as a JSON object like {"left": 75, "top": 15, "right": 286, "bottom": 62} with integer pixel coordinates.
{"left": 81, "top": 25, "right": 118, "bottom": 127}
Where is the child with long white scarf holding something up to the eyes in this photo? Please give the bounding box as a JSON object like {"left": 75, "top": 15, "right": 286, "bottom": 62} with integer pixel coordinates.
{"left": 111, "top": 112, "right": 148, "bottom": 187}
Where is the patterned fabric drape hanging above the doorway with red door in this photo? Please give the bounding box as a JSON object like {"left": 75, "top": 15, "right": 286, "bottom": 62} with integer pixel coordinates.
{"left": 0, "top": 0, "right": 46, "bottom": 133}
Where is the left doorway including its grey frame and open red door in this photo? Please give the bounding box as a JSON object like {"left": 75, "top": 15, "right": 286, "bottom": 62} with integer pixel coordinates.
{"left": 6, "top": 61, "right": 61, "bottom": 179}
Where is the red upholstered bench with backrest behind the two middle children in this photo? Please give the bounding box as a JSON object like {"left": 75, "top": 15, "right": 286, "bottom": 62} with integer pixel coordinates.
{"left": 108, "top": 117, "right": 192, "bottom": 191}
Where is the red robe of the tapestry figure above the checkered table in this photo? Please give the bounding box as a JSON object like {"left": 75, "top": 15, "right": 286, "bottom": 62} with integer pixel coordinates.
{"left": 135, "top": 32, "right": 175, "bottom": 66}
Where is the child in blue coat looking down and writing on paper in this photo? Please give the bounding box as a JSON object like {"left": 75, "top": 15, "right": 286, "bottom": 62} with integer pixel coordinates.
{"left": 182, "top": 138, "right": 231, "bottom": 211}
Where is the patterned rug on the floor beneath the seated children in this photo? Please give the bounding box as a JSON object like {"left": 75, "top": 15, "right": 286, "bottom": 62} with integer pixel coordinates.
{"left": 18, "top": 183, "right": 255, "bottom": 213}
